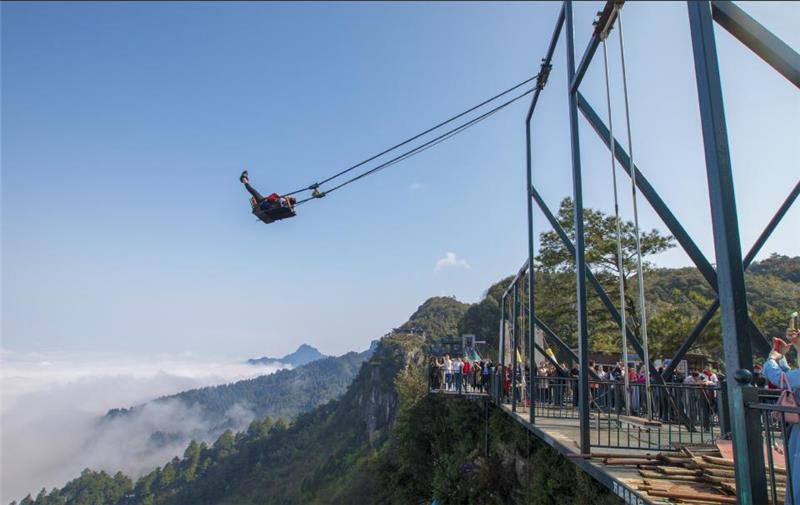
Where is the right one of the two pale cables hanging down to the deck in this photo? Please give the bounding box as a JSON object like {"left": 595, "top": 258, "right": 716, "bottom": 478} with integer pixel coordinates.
{"left": 617, "top": 12, "right": 653, "bottom": 418}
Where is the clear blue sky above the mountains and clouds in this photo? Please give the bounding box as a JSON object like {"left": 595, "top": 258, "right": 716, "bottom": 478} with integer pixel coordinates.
{"left": 2, "top": 2, "right": 800, "bottom": 357}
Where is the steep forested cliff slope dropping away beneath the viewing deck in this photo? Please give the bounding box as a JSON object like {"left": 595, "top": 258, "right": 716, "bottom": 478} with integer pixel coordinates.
{"left": 21, "top": 298, "right": 617, "bottom": 505}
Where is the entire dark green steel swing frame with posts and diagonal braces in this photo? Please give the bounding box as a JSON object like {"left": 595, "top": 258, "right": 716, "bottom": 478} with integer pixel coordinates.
{"left": 499, "top": 0, "right": 800, "bottom": 504}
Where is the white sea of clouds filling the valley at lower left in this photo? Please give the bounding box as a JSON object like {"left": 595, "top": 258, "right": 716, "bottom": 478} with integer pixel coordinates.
{"left": 0, "top": 350, "right": 283, "bottom": 504}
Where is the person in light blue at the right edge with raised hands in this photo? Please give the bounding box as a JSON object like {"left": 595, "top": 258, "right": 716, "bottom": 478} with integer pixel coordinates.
{"left": 764, "top": 330, "right": 800, "bottom": 504}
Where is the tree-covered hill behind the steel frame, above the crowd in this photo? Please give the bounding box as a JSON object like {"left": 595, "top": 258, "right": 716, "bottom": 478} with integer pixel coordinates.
{"left": 458, "top": 254, "right": 800, "bottom": 360}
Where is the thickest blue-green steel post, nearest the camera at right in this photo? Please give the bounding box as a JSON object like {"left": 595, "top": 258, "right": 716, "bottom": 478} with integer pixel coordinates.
{"left": 687, "top": 1, "right": 767, "bottom": 505}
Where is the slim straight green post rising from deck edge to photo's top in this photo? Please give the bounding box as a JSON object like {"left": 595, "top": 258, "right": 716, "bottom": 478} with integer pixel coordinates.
{"left": 564, "top": 0, "right": 591, "bottom": 454}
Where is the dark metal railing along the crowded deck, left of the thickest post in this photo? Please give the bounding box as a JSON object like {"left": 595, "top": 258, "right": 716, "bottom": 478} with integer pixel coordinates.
{"left": 428, "top": 367, "right": 732, "bottom": 448}
